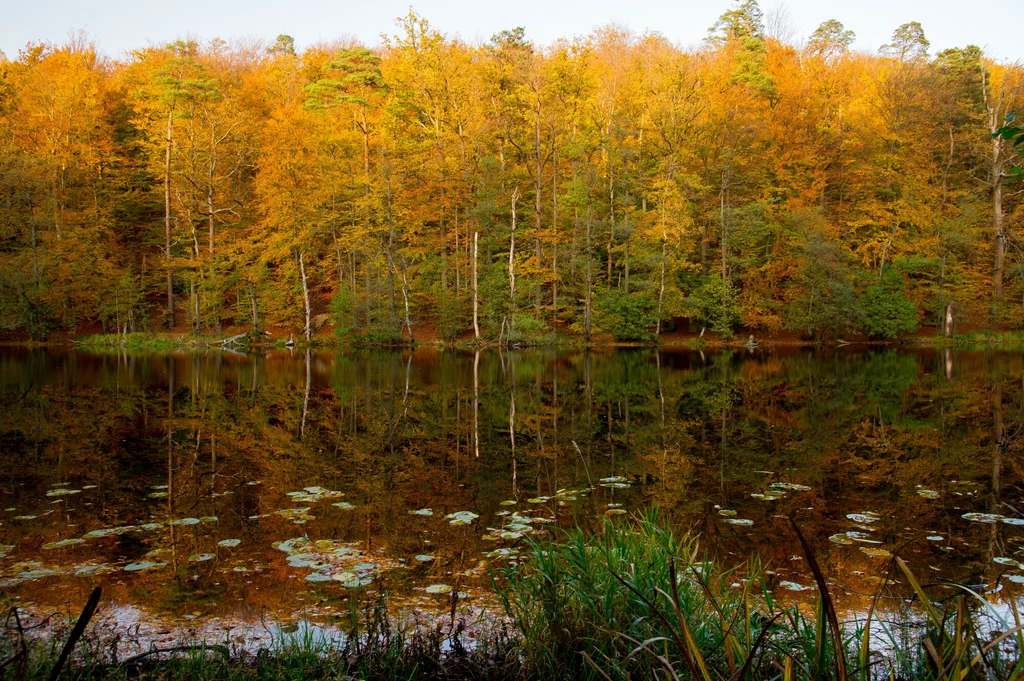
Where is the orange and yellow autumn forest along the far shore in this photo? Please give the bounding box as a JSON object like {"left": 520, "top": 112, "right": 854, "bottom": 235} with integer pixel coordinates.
{"left": 0, "top": 0, "right": 1024, "bottom": 344}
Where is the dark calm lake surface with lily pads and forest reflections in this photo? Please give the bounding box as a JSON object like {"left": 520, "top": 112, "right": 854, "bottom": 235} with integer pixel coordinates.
{"left": 0, "top": 348, "right": 1024, "bottom": 620}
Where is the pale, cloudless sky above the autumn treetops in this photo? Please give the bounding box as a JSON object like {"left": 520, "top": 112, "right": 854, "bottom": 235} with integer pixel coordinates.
{"left": 0, "top": 0, "right": 1024, "bottom": 61}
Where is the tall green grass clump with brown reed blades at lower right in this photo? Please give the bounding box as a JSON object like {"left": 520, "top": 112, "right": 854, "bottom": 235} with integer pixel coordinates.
{"left": 496, "top": 514, "right": 1024, "bottom": 681}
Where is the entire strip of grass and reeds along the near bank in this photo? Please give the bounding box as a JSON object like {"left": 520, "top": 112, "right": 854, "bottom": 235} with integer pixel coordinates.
{"left": 0, "top": 513, "right": 1024, "bottom": 681}
